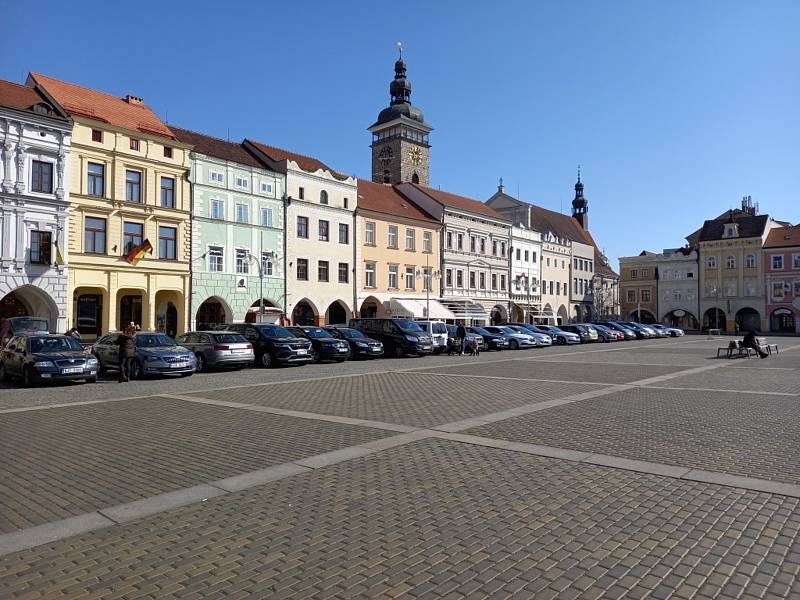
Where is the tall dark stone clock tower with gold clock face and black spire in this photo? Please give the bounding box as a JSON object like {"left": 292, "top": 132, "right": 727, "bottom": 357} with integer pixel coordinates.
{"left": 369, "top": 46, "right": 433, "bottom": 185}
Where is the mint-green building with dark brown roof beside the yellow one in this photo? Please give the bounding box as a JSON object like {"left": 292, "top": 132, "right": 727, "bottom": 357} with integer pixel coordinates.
{"left": 171, "top": 127, "right": 286, "bottom": 329}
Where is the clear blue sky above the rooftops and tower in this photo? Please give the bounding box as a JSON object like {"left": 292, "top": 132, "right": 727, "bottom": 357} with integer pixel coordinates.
{"left": 0, "top": 0, "right": 800, "bottom": 265}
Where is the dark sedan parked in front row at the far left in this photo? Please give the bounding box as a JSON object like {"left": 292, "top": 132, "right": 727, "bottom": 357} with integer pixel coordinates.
{"left": 0, "top": 333, "right": 98, "bottom": 387}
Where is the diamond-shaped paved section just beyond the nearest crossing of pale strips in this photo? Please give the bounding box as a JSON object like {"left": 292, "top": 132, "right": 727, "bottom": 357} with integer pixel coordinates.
{"left": 189, "top": 372, "right": 598, "bottom": 427}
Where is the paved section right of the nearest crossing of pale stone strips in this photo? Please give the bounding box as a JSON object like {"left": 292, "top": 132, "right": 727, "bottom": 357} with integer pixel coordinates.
{"left": 464, "top": 380, "right": 800, "bottom": 483}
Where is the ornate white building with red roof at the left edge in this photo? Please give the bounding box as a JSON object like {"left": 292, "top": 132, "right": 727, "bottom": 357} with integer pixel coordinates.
{"left": 0, "top": 81, "right": 72, "bottom": 332}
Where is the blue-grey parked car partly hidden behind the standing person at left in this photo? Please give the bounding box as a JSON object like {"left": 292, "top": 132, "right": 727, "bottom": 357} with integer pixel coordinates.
{"left": 91, "top": 331, "right": 197, "bottom": 379}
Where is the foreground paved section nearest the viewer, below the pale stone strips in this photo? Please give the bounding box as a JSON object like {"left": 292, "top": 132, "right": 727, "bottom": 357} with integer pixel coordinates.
{"left": 0, "top": 440, "right": 800, "bottom": 600}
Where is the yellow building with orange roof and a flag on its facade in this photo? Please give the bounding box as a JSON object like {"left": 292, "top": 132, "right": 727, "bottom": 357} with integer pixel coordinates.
{"left": 30, "top": 73, "right": 191, "bottom": 339}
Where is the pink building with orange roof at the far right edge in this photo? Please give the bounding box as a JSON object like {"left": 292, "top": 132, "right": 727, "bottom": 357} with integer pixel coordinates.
{"left": 764, "top": 225, "right": 800, "bottom": 333}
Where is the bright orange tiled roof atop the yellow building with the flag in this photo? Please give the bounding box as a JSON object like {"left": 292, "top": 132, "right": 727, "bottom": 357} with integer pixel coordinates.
{"left": 30, "top": 73, "right": 175, "bottom": 139}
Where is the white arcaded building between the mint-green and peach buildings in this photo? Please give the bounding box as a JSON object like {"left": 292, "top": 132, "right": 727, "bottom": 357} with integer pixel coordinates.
{"left": 244, "top": 140, "right": 358, "bottom": 325}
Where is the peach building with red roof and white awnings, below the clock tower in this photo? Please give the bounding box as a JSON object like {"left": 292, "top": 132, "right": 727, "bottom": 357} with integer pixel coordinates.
{"left": 355, "top": 179, "right": 453, "bottom": 319}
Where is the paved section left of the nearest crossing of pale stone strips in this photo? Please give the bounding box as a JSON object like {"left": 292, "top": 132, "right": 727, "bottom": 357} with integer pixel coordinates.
{"left": 0, "top": 398, "right": 391, "bottom": 528}
